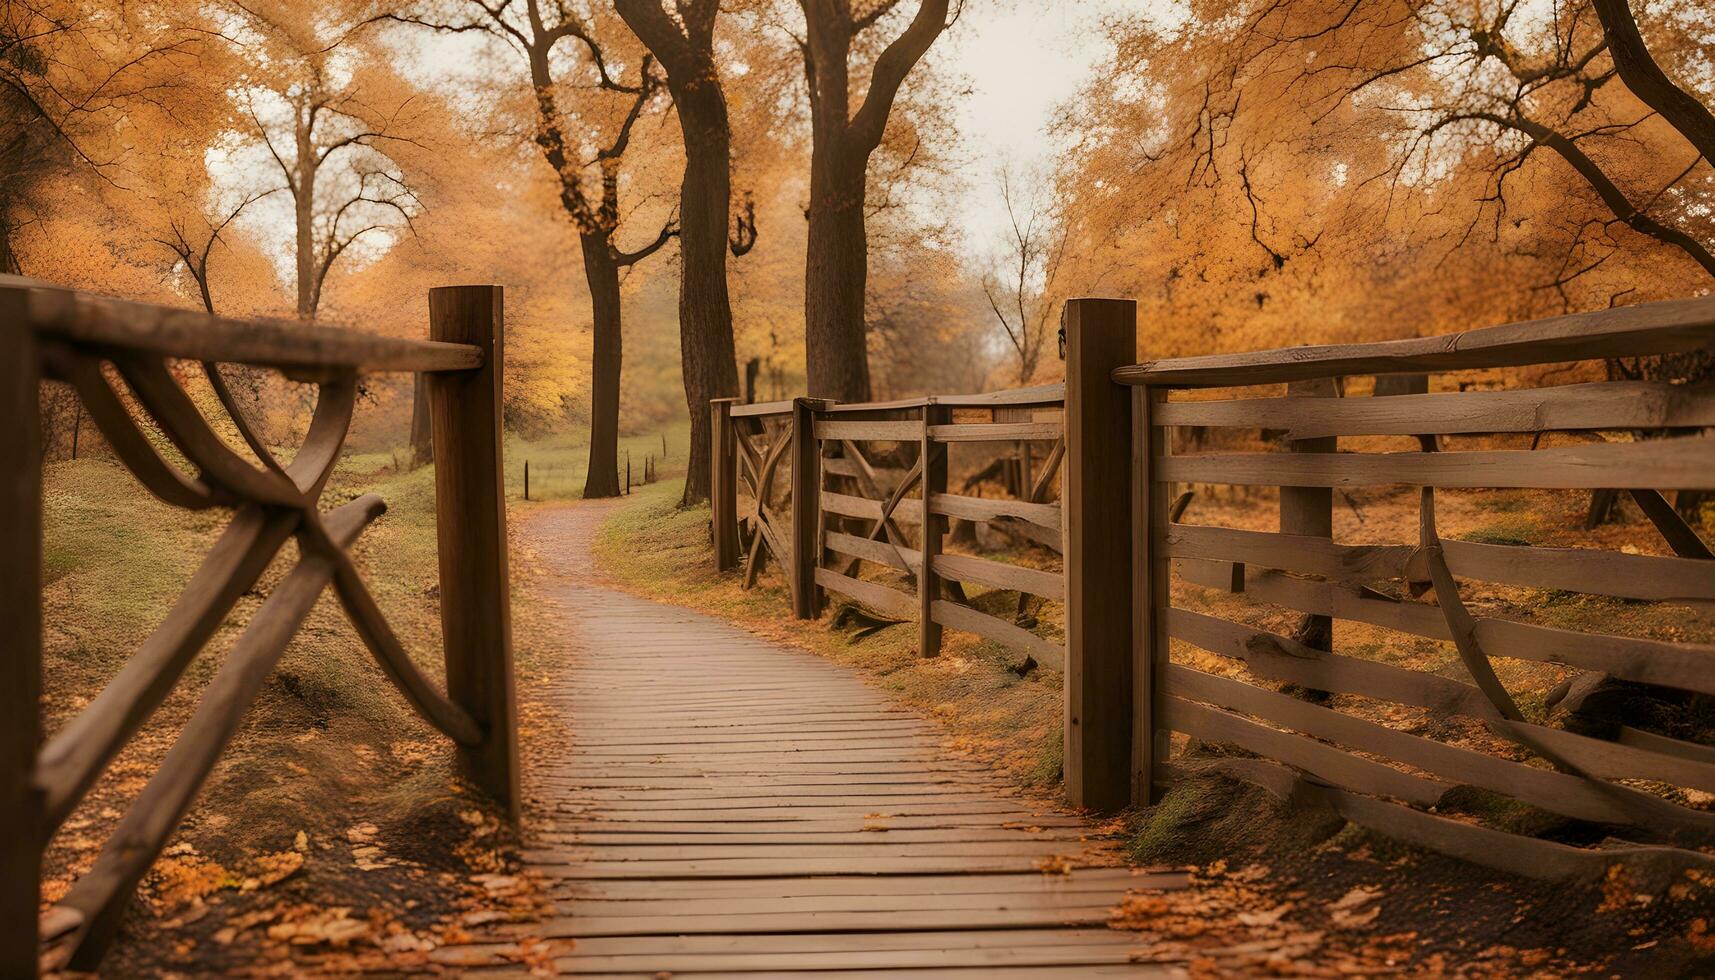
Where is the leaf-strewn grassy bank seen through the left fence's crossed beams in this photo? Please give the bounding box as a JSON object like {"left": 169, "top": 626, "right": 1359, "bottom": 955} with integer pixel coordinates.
{"left": 43, "top": 426, "right": 689, "bottom": 975}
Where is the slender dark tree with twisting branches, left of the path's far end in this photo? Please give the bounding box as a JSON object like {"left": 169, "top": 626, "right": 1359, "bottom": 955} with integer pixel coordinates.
{"left": 389, "top": 0, "right": 675, "bottom": 498}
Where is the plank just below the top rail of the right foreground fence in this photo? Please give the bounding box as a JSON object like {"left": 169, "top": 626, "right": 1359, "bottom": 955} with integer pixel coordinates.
{"left": 1161, "top": 381, "right": 1715, "bottom": 439}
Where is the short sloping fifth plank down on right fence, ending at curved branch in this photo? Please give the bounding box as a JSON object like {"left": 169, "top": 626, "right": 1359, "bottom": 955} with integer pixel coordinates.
{"left": 1168, "top": 609, "right": 1497, "bottom": 719}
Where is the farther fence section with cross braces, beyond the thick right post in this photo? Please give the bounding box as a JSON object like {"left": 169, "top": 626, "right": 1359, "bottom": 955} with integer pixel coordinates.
{"left": 712, "top": 384, "right": 1065, "bottom": 669}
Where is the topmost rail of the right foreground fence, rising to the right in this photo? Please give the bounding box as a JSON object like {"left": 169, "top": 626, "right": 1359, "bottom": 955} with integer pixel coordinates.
{"left": 1113, "top": 297, "right": 1715, "bottom": 386}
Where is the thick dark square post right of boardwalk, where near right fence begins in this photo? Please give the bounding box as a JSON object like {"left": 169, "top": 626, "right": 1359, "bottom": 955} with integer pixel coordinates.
{"left": 1062, "top": 299, "right": 1137, "bottom": 810}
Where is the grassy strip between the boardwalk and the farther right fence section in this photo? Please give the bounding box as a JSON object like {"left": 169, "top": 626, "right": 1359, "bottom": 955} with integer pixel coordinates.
{"left": 595, "top": 481, "right": 1062, "bottom": 793}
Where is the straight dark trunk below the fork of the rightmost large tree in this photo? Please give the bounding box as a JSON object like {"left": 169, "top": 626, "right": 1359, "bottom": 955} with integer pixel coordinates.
{"left": 804, "top": 145, "right": 870, "bottom": 402}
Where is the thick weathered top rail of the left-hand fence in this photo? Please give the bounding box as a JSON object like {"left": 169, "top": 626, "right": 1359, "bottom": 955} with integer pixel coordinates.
{"left": 13, "top": 276, "right": 484, "bottom": 372}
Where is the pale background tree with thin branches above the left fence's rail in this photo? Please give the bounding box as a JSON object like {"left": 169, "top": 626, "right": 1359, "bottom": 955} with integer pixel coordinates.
{"left": 222, "top": 3, "right": 422, "bottom": 319}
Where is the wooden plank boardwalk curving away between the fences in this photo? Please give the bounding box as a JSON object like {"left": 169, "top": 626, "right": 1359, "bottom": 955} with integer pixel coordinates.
{"left": 527, "top": 506, "right": 1183, "bottom": 977}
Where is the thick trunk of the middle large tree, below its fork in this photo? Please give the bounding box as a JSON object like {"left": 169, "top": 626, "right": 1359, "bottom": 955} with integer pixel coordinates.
{"left": 672, "top": 84, "right": 739, "bottom": 506}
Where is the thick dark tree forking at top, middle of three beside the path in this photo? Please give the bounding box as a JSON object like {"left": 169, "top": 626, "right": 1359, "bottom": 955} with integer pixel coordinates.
{"left": 614, "top": 0, "right": 756, "bottom": 505}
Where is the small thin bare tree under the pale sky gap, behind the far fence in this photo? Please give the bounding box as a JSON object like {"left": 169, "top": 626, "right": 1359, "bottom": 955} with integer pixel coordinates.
{"left": 983, "top": 170, "right": 1067, "bottom": 384}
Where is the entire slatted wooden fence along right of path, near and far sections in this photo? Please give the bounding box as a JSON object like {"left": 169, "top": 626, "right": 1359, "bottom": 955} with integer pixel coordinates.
{"left": 715, "top": 297, "right": 1715, "bottom": 877}
